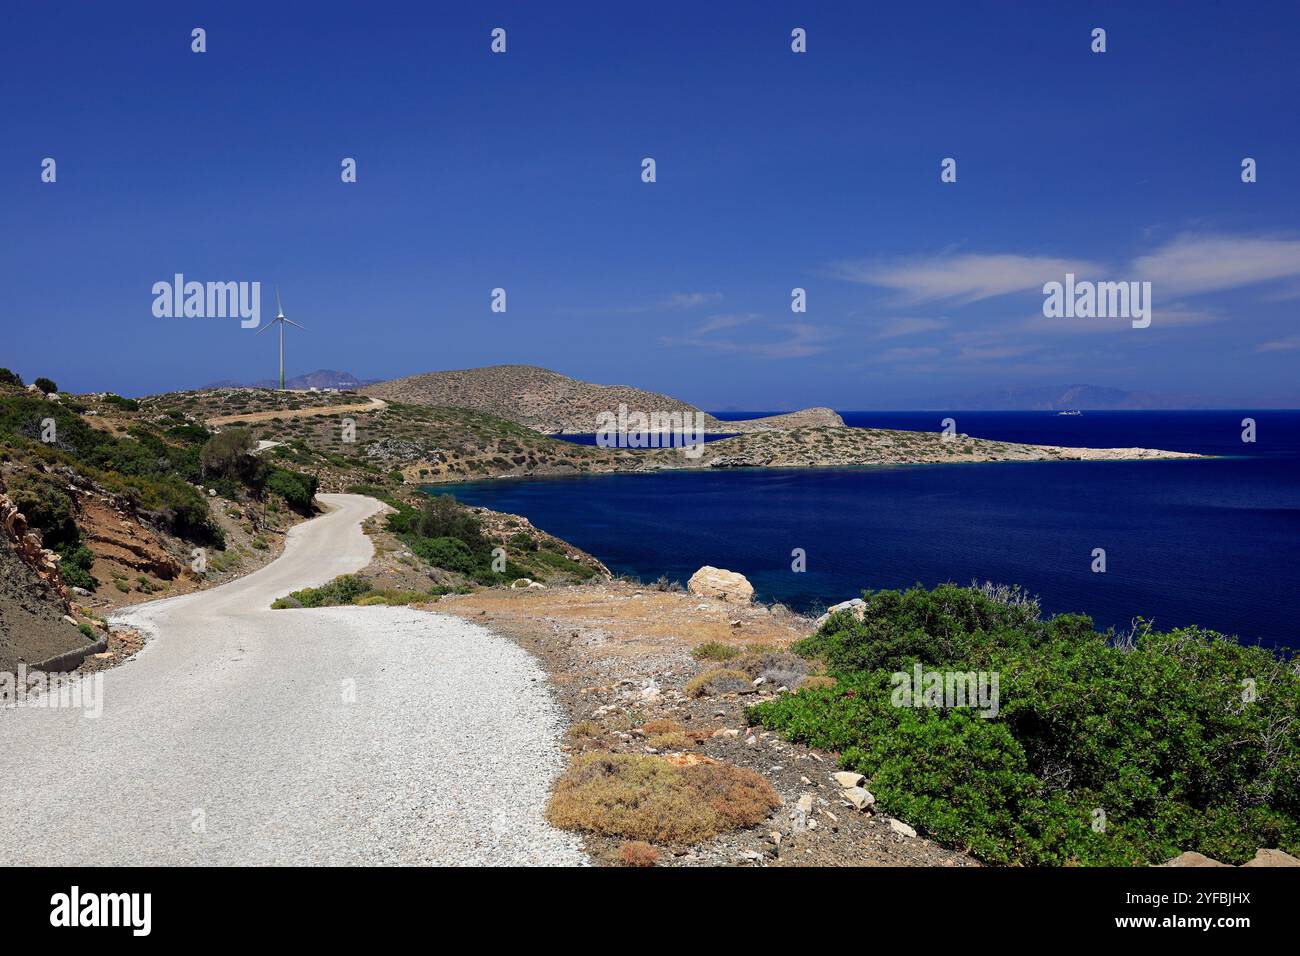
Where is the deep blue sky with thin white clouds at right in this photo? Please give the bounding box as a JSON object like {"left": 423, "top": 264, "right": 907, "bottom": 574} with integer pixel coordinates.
{"left": 0, "top": 0, "right": 1300, "bottom": 408}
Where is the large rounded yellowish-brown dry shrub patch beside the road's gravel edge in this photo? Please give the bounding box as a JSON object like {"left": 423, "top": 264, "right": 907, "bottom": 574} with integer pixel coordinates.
{"left": 546, "top": 753, "right": 781, "bottom": 844}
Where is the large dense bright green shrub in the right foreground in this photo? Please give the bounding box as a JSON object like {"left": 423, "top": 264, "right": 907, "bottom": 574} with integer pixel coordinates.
{"left": 749, "top": 585, "right": 1300, "bottom": 865}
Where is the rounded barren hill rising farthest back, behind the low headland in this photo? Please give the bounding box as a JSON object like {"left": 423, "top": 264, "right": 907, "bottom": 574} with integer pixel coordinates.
{"left": 360, "top": 365, "right": 844, "bottom": 434}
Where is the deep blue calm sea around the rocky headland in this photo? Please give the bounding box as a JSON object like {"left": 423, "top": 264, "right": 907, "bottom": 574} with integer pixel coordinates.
{"left": 438, "top": 411, "right": 1300, "bottom": 646}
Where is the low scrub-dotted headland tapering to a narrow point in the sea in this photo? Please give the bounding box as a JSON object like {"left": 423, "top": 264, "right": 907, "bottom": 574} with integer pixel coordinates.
{"left": 140, "top": 390, "right": 1191, "bottom": 493}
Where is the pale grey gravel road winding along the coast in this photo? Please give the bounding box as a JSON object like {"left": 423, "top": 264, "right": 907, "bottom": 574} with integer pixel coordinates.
{"left": 0, "top": 494, "right": 586, "bottom": 865}
